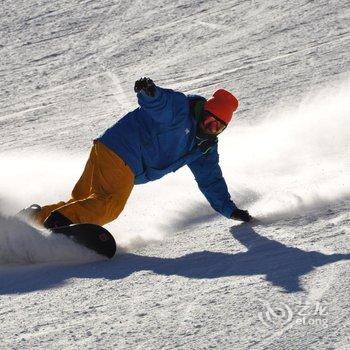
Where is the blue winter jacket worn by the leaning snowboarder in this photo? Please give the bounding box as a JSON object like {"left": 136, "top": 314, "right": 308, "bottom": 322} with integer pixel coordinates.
{"left": 98, "top": 87, "right": 236, "bottom": 218}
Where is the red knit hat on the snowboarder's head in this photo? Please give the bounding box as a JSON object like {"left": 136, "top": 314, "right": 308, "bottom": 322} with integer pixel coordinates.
{"left": 204, "top": 89, "right": 238, "bottom": 125}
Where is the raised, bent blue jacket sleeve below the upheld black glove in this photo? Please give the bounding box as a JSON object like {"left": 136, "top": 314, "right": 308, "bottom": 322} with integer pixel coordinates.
{"left": 137, "top": 86, "right": 188, "bottom": 124}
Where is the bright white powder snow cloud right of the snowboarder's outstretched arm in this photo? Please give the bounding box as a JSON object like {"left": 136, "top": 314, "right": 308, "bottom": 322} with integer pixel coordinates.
{"left": 222, "top": 80, "right": 350, "bottom": 221}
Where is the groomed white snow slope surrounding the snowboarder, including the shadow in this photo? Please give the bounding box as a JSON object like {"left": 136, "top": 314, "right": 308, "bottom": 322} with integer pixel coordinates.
{"left": 0, "top": 0, "right": 350, "bottom": 349}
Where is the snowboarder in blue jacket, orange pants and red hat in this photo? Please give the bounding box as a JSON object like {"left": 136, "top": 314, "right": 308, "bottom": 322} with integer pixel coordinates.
{"left": 21, "top": 78, "right": 251, "bottom": 228}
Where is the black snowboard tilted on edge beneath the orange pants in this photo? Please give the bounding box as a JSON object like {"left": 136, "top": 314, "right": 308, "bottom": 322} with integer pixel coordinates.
{"left": 50, "top": 224, "right": 117, "bottom": 259}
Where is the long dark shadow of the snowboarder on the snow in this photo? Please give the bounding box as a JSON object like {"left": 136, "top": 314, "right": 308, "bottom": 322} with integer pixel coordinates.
{"left": 0, "top": 224, "right": 350, "bottom": 294}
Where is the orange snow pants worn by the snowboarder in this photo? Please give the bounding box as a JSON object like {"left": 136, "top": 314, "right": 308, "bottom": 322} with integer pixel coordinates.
{"left": 36, "top": 141, "right": 135, "bottom": 225}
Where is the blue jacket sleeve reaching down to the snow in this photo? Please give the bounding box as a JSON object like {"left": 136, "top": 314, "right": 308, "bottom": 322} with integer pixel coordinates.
{"left": 188, "top": 146, "right": 236, "bottom": 218}
